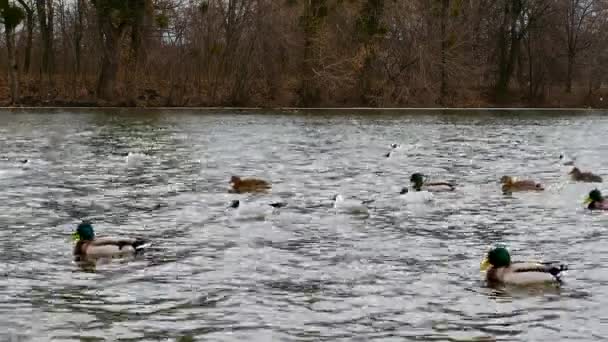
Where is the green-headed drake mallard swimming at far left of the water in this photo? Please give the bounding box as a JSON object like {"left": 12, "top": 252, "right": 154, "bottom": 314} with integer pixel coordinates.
{"left": 72, "top": 222, "right": 147, "bottom": 260}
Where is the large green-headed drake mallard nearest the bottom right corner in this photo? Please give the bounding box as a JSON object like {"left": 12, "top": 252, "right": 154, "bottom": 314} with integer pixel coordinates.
{"left": 481, "top": 246, "right": 568, "bottom": 285}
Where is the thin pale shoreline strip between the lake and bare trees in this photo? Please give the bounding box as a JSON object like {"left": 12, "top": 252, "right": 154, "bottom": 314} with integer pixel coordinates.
{"left": 0, "top": 106, "right": 605, "bottom": 111}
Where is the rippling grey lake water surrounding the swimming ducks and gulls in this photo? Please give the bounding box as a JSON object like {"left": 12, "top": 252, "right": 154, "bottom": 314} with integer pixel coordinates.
{"left": 0, "top": 110, "right": 608, "bottom": 341}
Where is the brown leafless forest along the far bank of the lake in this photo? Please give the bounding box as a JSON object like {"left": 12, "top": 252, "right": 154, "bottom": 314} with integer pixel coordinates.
{"left": 0, "top": 0, "right": 608, "bottom": 107}
